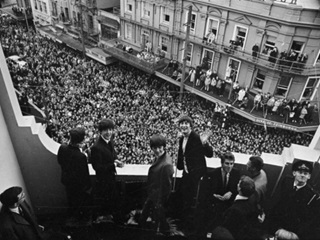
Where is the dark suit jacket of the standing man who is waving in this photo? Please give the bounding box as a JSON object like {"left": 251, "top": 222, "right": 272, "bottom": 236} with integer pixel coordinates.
{"left": 177, "top": 131, "right": 213, "bottom": 179}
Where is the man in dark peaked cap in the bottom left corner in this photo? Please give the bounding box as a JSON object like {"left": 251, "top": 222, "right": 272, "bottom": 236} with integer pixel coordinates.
{"left": 0, "top": 187, "right": 45, "bottom": 240}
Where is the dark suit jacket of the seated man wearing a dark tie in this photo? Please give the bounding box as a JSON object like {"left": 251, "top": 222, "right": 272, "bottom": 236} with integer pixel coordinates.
{"left": 208, "top": 167, "right": 240, "bottom": 206}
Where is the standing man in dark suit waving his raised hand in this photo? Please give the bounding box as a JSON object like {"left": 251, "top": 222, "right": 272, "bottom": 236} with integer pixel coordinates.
{"left": 177, "top": 116, "right": 213, "bottom": 233}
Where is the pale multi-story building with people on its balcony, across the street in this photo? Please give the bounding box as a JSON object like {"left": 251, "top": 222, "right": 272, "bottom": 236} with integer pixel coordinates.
{"left": 120, "top": 0, "right": 320, "bottom": 105}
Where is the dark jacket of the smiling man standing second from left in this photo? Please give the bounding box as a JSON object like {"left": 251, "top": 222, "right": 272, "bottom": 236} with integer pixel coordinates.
{"left": 90, "top": 136, "right": 116, "bottom": 181}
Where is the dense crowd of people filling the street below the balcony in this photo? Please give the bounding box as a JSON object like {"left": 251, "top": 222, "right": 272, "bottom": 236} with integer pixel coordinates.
{"left": 1, "top": 17, "right": 312, "bottom": 164}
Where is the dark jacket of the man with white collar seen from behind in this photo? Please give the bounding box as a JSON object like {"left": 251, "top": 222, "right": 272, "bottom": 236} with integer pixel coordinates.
{"left": 222, "top": 200, "right": 258, "bottom": 240}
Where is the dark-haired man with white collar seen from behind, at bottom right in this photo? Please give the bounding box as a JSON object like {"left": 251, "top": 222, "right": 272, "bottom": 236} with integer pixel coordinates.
{"left": 222, "top": 176, "right": 259, "bottom": 240}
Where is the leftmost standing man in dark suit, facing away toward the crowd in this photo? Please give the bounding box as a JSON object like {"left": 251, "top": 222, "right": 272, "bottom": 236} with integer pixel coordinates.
{"left": 57, "top": 128, "right": 91, "bottom": 225}
